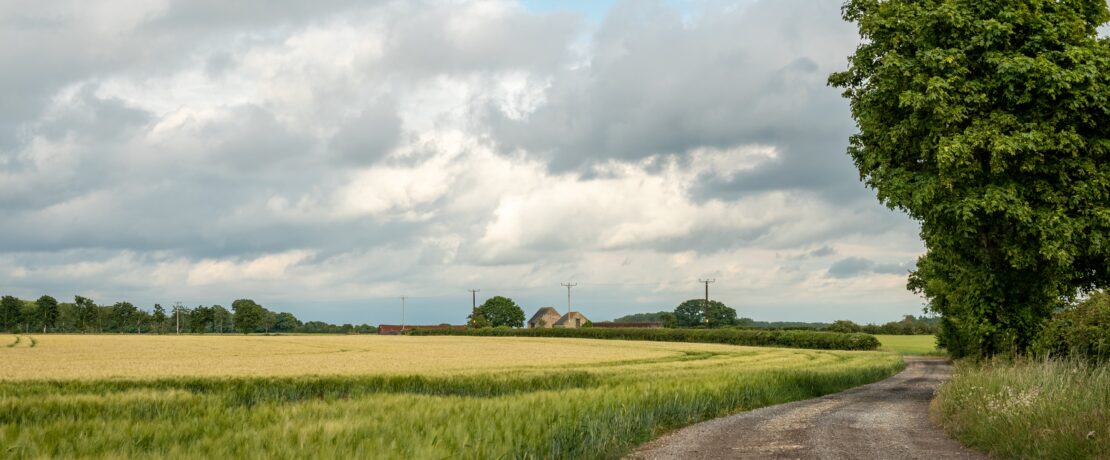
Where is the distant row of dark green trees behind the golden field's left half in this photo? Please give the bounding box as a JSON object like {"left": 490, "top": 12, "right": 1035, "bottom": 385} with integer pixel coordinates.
{"left": 0, "top": 296, "right": 377, "bottom": 333}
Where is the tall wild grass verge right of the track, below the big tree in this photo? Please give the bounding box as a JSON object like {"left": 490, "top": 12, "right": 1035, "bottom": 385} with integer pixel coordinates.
{"left": 932, "top": 360, "right": 1110, "bottom": 459}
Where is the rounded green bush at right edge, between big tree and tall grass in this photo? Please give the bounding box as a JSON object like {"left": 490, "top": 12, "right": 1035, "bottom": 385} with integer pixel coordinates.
{"left": 1033, "top": 291, "right": 1110, "bottom": 363}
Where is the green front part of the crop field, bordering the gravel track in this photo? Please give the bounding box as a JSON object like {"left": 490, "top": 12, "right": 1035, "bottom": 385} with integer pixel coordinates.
{"left": 0, "top": 338, "right": 902, "bottom": 459}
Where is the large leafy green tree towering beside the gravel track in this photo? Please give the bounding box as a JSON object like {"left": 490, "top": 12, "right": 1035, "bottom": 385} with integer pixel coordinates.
{"left": 829, "top": 0, "right": 1110, "bottom": 357}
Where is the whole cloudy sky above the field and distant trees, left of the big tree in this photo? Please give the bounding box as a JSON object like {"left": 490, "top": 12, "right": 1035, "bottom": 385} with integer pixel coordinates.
{"left": 0, "top": 0, "right": 941, "bottom": 323}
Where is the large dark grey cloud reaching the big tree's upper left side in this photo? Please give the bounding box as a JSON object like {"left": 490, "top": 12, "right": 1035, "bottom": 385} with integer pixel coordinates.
{"left": 491, "top": 0, "right": 858, "bottom": 201}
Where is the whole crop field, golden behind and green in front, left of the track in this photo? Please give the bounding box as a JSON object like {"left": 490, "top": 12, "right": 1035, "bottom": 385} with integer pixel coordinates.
{"left": 0, "top": 336, "right": 902, "bottom": 458}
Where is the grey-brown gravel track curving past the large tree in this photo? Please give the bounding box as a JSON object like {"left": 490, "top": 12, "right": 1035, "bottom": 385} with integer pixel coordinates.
{"left": 628, "top": 357, "right": 986, "bottom": 460}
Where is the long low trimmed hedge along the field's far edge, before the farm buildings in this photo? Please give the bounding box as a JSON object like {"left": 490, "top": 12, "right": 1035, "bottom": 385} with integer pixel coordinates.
{"left": 410, "top": 328, "right": 879, "bottom": 350}
